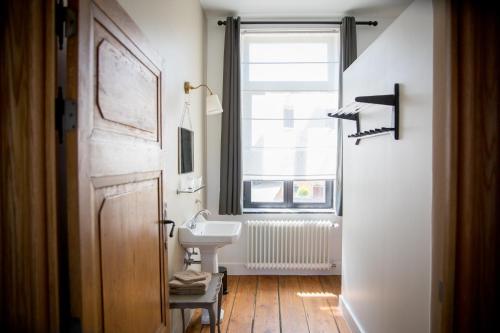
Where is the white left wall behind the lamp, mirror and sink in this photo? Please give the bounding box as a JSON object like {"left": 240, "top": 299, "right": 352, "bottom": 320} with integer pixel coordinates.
{"left": 114, "top": 0, "right": 205, "bottom": 332}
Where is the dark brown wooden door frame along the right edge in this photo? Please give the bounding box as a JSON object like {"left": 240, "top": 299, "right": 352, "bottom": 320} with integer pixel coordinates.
{"left": 431, "top": 0, "right": 500, "bottom": 332}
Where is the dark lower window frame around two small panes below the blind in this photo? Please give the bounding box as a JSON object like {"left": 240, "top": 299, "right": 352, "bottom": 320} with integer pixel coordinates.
{"left": 243, "top": 179, "right": 335, "bottom": 209}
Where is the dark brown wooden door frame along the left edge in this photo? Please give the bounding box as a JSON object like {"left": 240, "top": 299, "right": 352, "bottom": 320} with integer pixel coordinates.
{"left": 0, "top": 0, "right": 60, "bottom": 332}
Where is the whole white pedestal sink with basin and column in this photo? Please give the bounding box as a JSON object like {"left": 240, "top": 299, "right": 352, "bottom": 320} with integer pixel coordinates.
{"left": 179, "top": 216, "right": 241, "bottom": 324}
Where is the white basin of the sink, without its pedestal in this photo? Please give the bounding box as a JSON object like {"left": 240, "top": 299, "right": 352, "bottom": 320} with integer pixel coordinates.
{"left": 179, "top": 221, "right": 241, "bottom": 248}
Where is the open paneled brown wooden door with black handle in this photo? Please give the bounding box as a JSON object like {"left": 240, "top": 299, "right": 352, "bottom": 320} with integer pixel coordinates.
{"left": 68, "top": 0, "right": 169, "bottom": 332}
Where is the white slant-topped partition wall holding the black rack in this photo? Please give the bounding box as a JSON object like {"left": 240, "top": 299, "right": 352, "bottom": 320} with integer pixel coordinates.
{"left": 342, "top": 0, "right": 433, "bottom": 333}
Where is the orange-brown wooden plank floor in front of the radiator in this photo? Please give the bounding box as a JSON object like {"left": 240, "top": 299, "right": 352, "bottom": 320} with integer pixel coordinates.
{"left": 183, "top": 276, "right": 350, "bottom": 333}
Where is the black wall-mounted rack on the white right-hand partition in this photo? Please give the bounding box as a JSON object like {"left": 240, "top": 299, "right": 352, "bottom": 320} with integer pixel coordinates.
{"left": 328, "top": 83, "right": 399, "bottom": 145}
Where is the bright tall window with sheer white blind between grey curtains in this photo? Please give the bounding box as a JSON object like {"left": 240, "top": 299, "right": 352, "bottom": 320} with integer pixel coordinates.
{"left": 241, "top": 30, "right": 339, "bottom": 211}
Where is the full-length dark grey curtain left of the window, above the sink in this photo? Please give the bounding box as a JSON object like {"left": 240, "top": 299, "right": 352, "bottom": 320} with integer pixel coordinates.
{"left": 219, "top": 17, "right": 242, "bottom": 215}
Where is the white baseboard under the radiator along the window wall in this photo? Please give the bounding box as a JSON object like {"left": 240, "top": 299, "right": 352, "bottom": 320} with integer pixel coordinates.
{"left": 219, "top": 261, "right": 342, "bottom": 275}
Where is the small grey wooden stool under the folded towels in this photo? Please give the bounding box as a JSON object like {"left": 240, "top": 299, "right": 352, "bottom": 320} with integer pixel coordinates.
{"left": 169, "top": 273, "right": 224, "bottom": 333}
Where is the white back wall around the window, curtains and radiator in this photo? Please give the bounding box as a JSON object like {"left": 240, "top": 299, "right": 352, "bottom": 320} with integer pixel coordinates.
{"left": 206, "top": 13, "right": 404, "bottom": 274}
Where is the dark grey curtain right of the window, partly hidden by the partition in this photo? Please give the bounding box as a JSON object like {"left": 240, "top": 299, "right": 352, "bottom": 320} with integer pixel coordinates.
{"left": 335, "top": 16, "right": 358, "bottom": 216}
